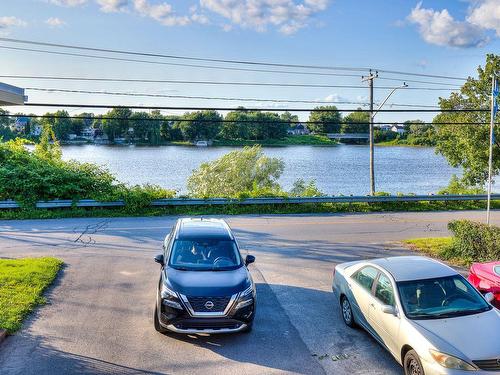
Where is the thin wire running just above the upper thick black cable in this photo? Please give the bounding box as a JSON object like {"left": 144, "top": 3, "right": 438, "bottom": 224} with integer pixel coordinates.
{"left": 25, "top": 87, "right": 440, "bottom": 108}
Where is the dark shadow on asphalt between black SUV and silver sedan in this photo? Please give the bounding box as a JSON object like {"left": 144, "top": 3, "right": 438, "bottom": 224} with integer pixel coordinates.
{"left": 156, "top": 283, "right": 400, "bottom": 374}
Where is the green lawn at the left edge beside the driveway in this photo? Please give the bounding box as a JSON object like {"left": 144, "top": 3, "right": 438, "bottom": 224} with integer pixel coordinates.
{"left": 0, "top": 258, "right": 62, "bottom": 333}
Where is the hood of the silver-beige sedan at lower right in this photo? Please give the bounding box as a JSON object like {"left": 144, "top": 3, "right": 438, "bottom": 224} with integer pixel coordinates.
{"left": 412, "top": 309, "right": 500, "bottom": 360}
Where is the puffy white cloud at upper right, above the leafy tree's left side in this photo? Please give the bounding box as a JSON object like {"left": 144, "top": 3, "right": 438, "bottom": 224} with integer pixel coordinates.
{"left": 408, "top": 2, "right": 488, "bottom": 47}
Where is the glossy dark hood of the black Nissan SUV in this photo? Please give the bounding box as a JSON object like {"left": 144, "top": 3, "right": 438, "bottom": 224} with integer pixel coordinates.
{"left": 165, "top": 267, "right": 251, "bottom": 297}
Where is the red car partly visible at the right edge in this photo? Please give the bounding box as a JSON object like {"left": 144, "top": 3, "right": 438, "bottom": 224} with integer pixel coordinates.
{"left": 468, "top": 261, "right": 500, "bottom": 309}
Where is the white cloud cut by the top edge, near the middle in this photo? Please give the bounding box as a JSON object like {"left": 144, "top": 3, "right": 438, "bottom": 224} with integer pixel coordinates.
{"left": 200, "top": 0, "right": 329, "bottom": 34}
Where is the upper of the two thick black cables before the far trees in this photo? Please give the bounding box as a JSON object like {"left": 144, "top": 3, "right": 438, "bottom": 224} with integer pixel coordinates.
{"left": 21, "top": 102, "right": 489, "bottom": 113}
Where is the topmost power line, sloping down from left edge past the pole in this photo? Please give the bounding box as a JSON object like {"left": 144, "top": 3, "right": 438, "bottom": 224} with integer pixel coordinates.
{"left": 0, "top": 38, "right": 466, "bottom": 81}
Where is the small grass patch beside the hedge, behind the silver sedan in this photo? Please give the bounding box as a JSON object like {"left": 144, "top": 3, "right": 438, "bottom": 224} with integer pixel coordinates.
{"left": 403, "top": 237, "right": 470, "bottom": 266}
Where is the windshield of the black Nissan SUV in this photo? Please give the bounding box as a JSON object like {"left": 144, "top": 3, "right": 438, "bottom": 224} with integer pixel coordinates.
{"left": 170, "top": 239, "right": 242, "bottom": 271}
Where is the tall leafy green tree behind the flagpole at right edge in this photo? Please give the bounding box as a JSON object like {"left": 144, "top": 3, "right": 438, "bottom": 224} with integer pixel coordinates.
{"left": 434, "top": 54, "right": 500, "bottom": 185}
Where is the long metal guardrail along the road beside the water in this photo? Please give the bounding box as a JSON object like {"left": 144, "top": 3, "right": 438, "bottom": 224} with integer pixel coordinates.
{"left": 0, "top": 194, "right": 500, "bottom": 209}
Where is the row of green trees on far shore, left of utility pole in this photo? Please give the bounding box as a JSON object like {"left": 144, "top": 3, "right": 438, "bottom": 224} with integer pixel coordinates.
{"left": 0, "top": 106, "right": 376, "bottom": 144}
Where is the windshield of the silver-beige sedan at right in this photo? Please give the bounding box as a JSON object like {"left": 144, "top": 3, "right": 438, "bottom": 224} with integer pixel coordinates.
{"left": 397, "top": 275, "right": 491, "bottom": 319}
